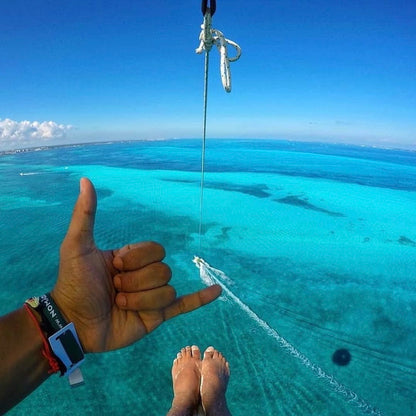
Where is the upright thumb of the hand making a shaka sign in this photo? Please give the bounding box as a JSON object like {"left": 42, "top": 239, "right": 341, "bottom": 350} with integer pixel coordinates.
{"left": 65, "top": 178, "right": 97, "bottom": 248}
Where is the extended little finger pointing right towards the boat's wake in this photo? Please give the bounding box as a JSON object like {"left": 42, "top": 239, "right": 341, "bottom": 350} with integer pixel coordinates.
{"left": 164, "top": 285, "right": 222, "bottom": 321}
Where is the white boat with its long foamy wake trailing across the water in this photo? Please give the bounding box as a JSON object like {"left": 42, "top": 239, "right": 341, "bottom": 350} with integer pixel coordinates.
{"left": 193, "top": 256, "right": 382, "bottom": 416}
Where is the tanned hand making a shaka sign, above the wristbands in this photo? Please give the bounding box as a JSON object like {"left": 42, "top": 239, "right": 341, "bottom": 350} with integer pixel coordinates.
{"left": 51, "top": 178, "right": 221, "bottom": 352}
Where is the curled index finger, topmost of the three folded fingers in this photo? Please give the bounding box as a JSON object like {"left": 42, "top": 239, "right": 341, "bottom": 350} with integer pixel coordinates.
{"left": 113, "top": 241, "right": 165, "bottom": 271}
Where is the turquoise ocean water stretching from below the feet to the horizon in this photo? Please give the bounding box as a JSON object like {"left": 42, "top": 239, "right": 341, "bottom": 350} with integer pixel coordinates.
{"left": 0, "top": 139, "right": 416, "bottom": 416}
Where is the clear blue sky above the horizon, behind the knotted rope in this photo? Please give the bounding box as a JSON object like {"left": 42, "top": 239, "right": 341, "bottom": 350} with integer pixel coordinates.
{"left": 0, "top": 0, "right": 416, "bottom": 149}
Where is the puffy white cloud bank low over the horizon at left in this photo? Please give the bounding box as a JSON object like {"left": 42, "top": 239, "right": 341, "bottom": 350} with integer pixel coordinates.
{"left": 0, "top": 118, "right": 72, "bottom": 149}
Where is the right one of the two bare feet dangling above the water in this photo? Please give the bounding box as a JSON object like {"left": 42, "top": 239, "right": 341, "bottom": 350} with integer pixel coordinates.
{"left": 200, "top": 347, "right": 231, "bottom": 416}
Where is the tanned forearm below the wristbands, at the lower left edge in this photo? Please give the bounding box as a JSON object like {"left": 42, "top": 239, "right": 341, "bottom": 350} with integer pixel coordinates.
{"left": 0, "top": 307, "right": 49, "bottom": 414}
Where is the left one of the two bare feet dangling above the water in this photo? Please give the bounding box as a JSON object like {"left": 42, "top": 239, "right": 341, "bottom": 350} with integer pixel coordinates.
{"left": 168, "top": 345, "right": 201, "bottom": 416}
